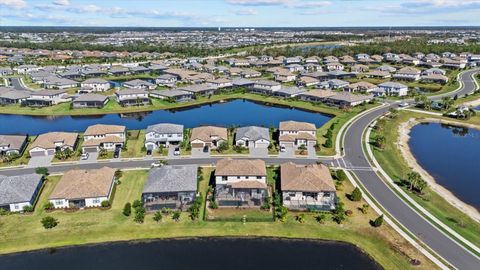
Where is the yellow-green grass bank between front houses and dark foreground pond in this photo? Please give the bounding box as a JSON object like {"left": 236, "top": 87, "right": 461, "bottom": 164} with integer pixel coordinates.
{"left": 0, "top": 170, "right": 435, "bottom": 269}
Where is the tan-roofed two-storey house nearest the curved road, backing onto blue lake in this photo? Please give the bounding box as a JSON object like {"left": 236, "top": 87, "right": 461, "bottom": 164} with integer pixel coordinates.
{"left": 278, "top": 121, "right": 317, "bottom": 149}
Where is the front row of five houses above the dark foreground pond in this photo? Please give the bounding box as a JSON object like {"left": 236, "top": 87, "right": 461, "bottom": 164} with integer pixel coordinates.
{"left": 0, "top": 158, "right": 336, "bottom": 212}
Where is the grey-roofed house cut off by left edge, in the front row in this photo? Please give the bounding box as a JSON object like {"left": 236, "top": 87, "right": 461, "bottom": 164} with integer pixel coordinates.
{"left": 0, "top": 173, "right": 43, "bottom": 212}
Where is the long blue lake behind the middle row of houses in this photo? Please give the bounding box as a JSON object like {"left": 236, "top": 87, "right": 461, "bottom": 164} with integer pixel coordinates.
{"left": 0, "top": 99, "right": 331, "bottom": 135}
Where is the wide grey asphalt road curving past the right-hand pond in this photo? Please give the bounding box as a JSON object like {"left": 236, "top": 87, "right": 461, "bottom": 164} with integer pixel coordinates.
{"left": 344, "top": 70, "right": 480, "bottom": 270}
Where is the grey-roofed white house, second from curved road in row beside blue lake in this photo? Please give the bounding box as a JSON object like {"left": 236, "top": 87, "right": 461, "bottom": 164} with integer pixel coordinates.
{"left": 235, "top": 126, "right": 270, "bottom": 148}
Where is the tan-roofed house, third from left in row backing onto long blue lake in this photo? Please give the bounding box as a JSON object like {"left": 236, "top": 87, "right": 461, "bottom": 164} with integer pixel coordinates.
{"left": 82, "top": 124, "right": 127, "bottom": 153}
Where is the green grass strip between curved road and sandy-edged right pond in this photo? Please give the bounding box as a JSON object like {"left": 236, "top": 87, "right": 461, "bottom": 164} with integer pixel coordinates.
{"left": 370, "top": 111, "right": 480, "bottom": 246}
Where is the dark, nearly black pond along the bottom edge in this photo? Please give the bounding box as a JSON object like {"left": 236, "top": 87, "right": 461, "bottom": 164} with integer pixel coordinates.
{"left": 0, "top": 238, "right": 381, "bottom": 270}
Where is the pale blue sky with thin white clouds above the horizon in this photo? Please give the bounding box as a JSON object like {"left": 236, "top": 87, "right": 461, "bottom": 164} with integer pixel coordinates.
{"left": 0, "top": 0, "right": 480, "bottom": 27}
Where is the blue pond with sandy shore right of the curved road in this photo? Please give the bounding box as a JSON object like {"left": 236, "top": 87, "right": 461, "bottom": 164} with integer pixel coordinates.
{"left": 409, "top": 123, "right": 480, "bottom": 209}
